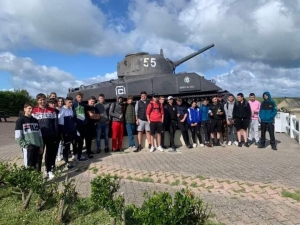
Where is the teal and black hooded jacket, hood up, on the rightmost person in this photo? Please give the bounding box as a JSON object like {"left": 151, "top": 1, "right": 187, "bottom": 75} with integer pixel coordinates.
{"left": 259, "top": 91, "right": 277, "bottom": 123}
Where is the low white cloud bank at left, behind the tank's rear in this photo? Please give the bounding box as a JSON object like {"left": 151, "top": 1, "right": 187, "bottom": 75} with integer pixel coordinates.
{"left": 0, "top": 52, "right": 117, "bottom": 96}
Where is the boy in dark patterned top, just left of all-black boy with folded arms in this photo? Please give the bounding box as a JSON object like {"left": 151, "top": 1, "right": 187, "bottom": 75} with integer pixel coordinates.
{"left": 72, "top": 92, "right": 87, "bottom": 162}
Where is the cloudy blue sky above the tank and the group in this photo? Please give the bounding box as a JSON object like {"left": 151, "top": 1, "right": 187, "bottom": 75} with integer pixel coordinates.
{"left": 0, "top": 0, "right": 300, "bottom": 97}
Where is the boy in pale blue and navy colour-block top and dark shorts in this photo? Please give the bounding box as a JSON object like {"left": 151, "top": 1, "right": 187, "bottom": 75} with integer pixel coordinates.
{"left": 58, "top": 97, "right": 77, "bottom": 169}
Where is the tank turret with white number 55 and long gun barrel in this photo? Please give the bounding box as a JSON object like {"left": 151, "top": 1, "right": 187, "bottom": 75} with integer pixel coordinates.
{"left": 117, "top": 44, "right": 214, "bottom": 79}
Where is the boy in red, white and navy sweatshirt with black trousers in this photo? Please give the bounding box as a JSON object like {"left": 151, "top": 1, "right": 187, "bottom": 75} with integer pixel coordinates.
{"left": 32, "top": 93, "right": 58, "bottom": 179}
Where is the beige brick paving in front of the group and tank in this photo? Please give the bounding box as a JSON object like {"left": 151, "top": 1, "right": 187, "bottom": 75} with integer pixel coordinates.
{"left": 0, "top": 118, "right": 300, "bottom": 225}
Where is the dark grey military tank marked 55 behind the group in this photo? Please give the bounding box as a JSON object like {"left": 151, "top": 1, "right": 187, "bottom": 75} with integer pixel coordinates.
{"left": 68, "top": 44, "right": 228, "bottom": 102}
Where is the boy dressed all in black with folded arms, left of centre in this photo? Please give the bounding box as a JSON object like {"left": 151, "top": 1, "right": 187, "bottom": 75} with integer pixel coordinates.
{"left": 84, "top": 96, "right": 100, "bottom": 159}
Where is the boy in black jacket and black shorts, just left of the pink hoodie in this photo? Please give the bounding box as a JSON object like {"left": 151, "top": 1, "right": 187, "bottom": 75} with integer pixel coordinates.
{"left": 232, "top": 93, "right": 251, "bottom": 147}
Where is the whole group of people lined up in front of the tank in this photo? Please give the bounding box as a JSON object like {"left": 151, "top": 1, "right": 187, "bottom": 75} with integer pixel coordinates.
{"left": 15, "top": 91, "right": 277, "bottom": 179}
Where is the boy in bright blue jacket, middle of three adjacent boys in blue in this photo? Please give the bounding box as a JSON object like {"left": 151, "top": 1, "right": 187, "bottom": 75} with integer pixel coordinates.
{"left": 187, "top": 101, "right": 204, "bottom": 148}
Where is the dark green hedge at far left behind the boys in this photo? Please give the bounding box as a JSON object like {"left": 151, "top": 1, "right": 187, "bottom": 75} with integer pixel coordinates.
{"left": 0, "top": 90, "right": 36, "bottom": 116}
